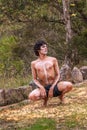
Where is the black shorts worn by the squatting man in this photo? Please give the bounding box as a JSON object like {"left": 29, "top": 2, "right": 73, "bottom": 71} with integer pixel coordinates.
{"left": 45, "top": 85, "right": 62, "bottom": 97}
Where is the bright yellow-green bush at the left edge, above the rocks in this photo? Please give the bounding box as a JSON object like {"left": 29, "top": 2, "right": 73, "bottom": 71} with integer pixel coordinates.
{"left": 0, "top": 36, "right": 23, "bottom": 76}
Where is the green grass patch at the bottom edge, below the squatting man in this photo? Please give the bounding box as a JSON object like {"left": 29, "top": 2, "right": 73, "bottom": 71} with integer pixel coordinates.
{"left": 19, "top": 118, "right": 56, "bottom": 130}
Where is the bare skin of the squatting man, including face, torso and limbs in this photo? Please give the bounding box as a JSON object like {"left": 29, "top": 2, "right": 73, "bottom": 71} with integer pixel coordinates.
{"left": 29, "top": 45, "right": 72, "bottom": 106}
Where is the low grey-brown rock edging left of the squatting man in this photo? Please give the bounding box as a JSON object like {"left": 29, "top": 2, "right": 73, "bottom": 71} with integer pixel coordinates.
{"left": 0, "top": 86, "right": 31, "bottom": 106}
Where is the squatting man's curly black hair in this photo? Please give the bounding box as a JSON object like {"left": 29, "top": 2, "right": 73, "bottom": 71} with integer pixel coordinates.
{"left": 34, "top": 40, "right": 47, "bottom": 56}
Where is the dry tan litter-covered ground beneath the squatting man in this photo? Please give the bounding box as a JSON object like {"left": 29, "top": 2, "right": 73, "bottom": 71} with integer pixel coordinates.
{"left": 0, "top": 83, "right": 87, "bottom": 130}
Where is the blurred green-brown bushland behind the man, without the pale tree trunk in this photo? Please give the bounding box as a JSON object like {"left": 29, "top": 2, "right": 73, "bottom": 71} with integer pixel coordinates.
{"left": 0, "top": 0, "right": 87, "bottom": 77}
